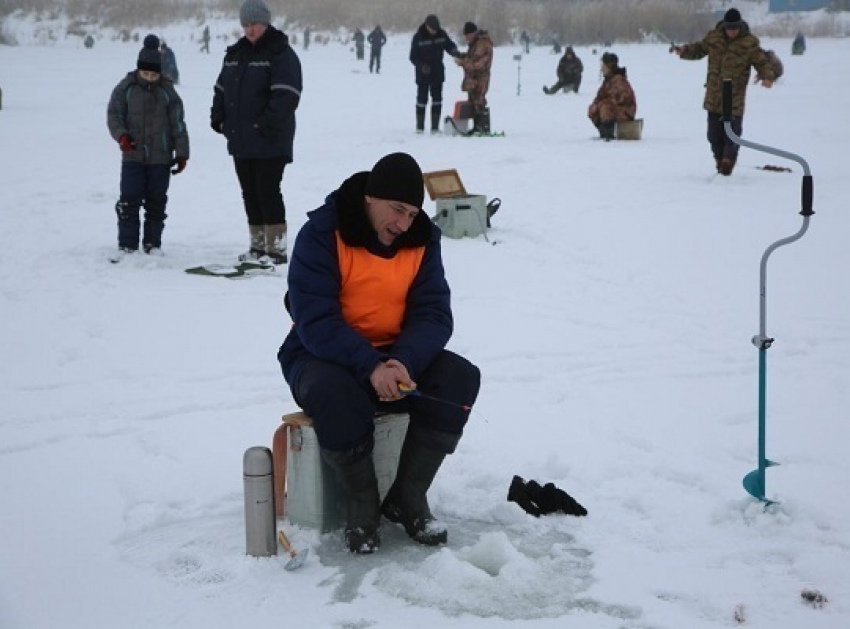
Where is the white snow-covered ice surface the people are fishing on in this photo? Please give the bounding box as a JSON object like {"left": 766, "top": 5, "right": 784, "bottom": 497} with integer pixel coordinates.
{"left": 0, "top": 8, "right": 850, "bottom": 629}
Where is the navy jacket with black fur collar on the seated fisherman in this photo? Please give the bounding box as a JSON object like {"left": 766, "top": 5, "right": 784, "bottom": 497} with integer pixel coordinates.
{"left": 278, "top": 172, "right": 454, "bottom": 386}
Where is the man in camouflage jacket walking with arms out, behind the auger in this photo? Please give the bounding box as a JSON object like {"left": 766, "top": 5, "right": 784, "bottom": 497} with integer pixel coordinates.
{"left": 672, "top": 9, "right": 776, "bottom": 176}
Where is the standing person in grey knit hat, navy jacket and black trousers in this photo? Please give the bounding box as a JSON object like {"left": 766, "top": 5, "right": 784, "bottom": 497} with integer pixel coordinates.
{"left": 210, "top": 0, "right": 301, "bottom": 264}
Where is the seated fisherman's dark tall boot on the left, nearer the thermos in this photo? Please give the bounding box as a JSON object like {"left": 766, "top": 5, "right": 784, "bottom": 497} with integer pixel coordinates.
{"left": 321, "top": 438, "right": 381, "bottom": 555}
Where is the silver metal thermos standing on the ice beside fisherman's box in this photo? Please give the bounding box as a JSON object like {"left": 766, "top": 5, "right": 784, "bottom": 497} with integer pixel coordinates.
{"left": 242, "top": 446, "right": 277, "bottom": 557}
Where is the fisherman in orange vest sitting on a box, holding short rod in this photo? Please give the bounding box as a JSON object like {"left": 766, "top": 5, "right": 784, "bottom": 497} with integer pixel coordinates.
{"left": 278, "top": 153, "right": 481, "bottom": 553}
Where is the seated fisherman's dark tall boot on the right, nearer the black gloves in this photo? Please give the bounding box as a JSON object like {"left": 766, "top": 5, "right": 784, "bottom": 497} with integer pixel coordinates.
{"left": 381, "top": 424, "right": 460, "bottom": 546}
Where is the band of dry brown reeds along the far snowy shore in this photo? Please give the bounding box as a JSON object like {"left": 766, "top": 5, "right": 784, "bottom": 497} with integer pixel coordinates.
{"left": 0, "top": 0, "right": 850, "bottom": 45}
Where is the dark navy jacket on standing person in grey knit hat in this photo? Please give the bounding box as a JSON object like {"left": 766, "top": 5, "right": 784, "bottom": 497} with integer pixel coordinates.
{"left": 210, "top": 26, "right": 302, "bottom": 162}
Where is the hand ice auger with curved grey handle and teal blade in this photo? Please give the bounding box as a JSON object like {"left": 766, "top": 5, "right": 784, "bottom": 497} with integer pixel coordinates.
{"left": 723, "top": 79, "right": 815, "bottom": 504}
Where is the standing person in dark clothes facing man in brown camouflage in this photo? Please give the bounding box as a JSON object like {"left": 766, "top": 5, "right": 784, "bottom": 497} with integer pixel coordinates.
{"left": 410, "top": 15, "right": 461, "bottom": 133}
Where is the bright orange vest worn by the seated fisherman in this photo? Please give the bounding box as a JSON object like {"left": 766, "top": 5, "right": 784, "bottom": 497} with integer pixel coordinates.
{"left": 336, "top": 231, "right": 425, "bottom": 347}
